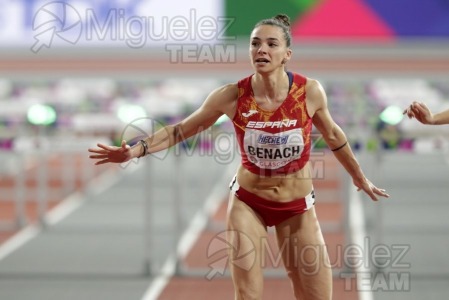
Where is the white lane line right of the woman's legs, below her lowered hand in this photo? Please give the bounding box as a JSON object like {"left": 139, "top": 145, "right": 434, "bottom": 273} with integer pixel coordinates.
{"left": 348, "top": 185, "right": 373, "bottom": 300}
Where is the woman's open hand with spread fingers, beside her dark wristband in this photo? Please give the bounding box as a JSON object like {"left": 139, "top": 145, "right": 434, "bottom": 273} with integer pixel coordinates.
{"left": 88, "top": 140, "right": 133, "bottom": 165}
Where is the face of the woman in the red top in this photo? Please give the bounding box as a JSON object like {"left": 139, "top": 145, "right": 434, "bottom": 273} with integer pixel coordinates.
{"left": 249, "top": 25, "right": 291, "bottom": 72}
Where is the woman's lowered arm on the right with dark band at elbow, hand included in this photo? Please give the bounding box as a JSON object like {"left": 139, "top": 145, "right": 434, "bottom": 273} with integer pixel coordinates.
{"left": 306, "top": 80, "right": 389, "bottom": 200}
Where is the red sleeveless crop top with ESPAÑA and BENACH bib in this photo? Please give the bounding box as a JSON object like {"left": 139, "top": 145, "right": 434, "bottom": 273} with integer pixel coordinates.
{"left": 232, "top": 73, "right": 312, "bottom": 176}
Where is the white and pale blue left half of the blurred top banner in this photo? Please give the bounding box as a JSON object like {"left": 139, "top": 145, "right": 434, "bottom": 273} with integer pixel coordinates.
{"left": 0, "top": 0, "right": 226, "bottom": 52}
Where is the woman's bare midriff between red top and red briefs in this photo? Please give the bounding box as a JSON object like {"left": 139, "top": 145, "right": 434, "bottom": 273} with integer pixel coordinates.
{"left": 237, "top": 164, "right": 312, "bottom": 202}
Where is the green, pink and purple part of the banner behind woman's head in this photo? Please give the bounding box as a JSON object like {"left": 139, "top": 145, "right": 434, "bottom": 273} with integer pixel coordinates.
{"left": 225, "top": 0, "right": 449, "bottom": 42}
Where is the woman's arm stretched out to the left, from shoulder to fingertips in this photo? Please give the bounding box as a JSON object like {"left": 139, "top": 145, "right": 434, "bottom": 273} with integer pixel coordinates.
{"left": 88, "top": 84, "right": 238, "bottom": 165}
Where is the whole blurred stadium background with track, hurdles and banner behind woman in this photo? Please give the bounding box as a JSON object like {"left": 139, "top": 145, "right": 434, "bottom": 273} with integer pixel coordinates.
{"left": 0, "top": 0, "right": 449, "bottom": 300}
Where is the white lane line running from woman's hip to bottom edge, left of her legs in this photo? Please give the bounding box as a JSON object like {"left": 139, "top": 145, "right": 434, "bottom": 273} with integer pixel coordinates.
{"left": 142, "top": 164, "right": 236, "bottom": 300}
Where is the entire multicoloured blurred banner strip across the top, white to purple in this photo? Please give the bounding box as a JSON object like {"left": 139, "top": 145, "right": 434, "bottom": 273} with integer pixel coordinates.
{"left": 0, "top": 0, "right": 449, "bottom": 52}
